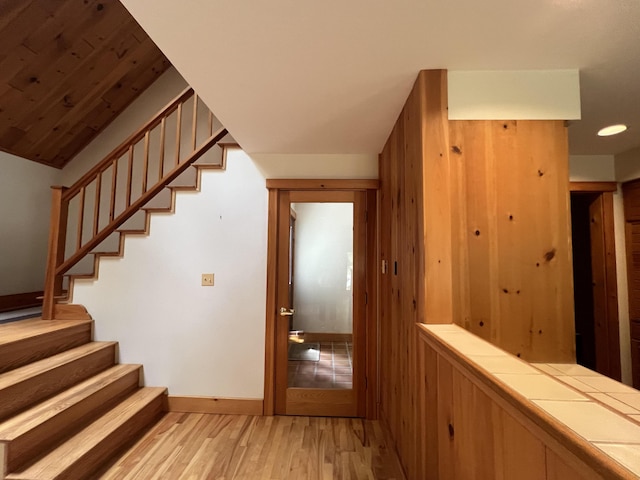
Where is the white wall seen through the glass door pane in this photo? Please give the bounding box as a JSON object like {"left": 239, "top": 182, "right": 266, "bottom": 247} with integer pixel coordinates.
{"left": 293, "top": 203, "right": 353, "bottom": 333}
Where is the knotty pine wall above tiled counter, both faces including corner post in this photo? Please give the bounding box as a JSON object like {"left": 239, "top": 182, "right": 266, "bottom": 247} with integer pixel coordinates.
{"left": 379, "top": 70, "right": 574, "bottom": 478}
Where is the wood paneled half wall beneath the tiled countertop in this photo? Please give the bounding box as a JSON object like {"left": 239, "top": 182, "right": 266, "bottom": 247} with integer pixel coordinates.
{"left": 416, "top": 329, "right": 635, "bottom": 480}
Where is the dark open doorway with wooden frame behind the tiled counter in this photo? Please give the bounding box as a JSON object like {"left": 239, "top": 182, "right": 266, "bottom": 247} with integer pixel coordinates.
{"left": 570, "top": 182, "right": 621, "bottom": 380}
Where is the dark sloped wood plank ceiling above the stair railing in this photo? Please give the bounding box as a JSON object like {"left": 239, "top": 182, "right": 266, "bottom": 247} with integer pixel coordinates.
{"left": 0, "top": 0, "right": 170, "bottom": 168}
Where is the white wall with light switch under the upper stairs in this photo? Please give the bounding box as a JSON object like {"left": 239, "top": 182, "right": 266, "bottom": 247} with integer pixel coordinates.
{"left": 73, "top": 151, "right": 267, "bottom": 398}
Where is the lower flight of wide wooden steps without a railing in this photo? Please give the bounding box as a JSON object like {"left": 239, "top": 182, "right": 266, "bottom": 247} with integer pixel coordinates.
{"left": 0, "top": 315, "right": 166, "bottom": 480}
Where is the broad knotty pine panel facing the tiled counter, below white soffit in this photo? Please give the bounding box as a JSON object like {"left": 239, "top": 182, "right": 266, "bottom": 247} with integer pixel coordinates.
{"left": 449, "top": 121, "right": 575, "bottom": 362}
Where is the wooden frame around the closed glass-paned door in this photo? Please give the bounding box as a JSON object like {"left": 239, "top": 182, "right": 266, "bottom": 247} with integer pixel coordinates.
{"left": 263, "top": 179, "right": 380, "bottom": 419}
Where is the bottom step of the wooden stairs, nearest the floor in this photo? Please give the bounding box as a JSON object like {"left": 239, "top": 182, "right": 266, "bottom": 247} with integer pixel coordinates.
{"left": 6, "top": 387, "right": 166, "bottom": 480}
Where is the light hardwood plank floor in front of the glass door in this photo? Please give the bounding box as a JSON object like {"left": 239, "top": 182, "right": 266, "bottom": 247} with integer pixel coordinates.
{"left": 96, "top": 413, "right": 405, "bottom": 480}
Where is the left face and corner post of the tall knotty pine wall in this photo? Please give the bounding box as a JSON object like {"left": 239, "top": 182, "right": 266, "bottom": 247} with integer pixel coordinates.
{"left": 380, "top": 71, "right": 452, "bottom": 478}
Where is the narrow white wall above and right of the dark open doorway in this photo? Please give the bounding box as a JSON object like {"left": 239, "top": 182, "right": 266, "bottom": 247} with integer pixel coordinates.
{"left": 569, "top": 155, "right": 632, "bottom": 385}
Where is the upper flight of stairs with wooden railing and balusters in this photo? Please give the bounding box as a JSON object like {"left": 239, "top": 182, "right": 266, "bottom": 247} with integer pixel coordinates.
{"left": 42, "top": 88, "right": 233, "bottom": 320}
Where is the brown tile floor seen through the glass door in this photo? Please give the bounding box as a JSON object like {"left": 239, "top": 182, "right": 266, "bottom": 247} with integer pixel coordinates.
{"left": 289, "top": 342, "right": 353, "bottom": 389}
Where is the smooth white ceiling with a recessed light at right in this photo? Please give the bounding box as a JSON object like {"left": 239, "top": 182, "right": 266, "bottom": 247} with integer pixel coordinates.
{"left": 121, "top": 0, "right": 640, "bottom": 154}
